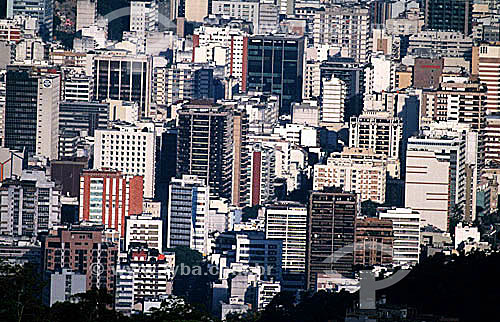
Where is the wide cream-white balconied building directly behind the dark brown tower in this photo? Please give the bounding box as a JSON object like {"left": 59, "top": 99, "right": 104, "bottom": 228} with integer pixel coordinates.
{"left": 313, "top": 148, "right": 387, "bottom": 203}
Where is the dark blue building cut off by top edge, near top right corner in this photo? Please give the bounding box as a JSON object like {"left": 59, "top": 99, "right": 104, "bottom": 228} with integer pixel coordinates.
{"left": 424, "top": 0, "right": 473, "bottom": 35}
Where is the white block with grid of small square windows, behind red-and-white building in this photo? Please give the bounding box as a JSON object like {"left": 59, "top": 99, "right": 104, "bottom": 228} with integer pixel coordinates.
{"left": 94, "top": 124, "right": 156, "bottom": 198}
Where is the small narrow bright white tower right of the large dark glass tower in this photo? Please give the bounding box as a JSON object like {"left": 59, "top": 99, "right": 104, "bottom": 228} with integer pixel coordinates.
{"left": 320, "top": 76, "right": 347, "bottom": 125}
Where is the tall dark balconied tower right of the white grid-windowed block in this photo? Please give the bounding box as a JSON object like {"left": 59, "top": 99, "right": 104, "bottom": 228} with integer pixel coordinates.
{"left": 177, "top": 104, "right": 233, "bottom": 199}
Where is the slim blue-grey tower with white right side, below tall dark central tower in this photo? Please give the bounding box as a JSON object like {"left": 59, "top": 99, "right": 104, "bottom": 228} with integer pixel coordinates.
{"left": 166, "top": 175, "right": 210, "bottom": 254}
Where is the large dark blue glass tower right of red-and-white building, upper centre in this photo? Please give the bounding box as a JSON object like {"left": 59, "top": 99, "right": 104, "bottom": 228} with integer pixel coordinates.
{"left": 243, "top": 35, "right": 304, "bottom": 114}
